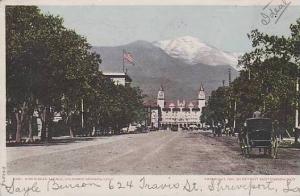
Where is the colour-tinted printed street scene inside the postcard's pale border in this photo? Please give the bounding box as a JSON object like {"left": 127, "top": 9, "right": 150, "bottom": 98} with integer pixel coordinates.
{"left": 0, "top": 0, "right": 300, "bottom": 179}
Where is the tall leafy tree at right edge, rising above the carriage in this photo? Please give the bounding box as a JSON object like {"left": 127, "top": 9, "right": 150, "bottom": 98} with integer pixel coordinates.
{"left": 235, "top": 20, "right": 299, "bottom": 131}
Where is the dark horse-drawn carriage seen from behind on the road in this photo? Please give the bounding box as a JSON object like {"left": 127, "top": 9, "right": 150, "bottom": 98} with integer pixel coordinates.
{"left": 239, "top": 118, "right": 278, "bottom": 158}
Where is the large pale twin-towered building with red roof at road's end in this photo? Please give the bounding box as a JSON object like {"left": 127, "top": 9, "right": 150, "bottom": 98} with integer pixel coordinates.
{"left": 151, "top": 84, "right": 205, "bottom": 128}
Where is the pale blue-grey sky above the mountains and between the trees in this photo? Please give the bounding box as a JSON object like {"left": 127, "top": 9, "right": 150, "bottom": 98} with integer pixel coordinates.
{"left": 40, "top": 6, "right": 300, "bottom": 53}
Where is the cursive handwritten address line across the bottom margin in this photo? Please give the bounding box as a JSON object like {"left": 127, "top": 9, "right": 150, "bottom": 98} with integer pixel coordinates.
{"left": 1, "top": 177, "right": 300, "bottom": 196}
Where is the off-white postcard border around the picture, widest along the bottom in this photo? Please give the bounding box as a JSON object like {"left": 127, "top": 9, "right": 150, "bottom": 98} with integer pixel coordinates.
{"left": 0, "top": 0, "right": 300, "bottom": 196}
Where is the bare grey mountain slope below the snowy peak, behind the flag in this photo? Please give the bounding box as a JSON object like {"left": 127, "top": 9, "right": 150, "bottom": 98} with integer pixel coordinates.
{"left": 93, "top": 41, "right": 238, "bottom": 99}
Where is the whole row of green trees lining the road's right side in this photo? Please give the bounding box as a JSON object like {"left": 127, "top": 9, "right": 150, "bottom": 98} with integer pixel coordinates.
{"left": 201, "top": 19, "right": 300, "bottom": 135}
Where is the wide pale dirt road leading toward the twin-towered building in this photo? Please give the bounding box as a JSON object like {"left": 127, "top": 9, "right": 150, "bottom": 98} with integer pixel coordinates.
{"left": 7, "top": 131, "right": 300, "bottom": 175}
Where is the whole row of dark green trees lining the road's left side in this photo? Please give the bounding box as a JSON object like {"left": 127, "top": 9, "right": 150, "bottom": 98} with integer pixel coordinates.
{"left": 6, "top": 6, "right": 143, "bottom": 142}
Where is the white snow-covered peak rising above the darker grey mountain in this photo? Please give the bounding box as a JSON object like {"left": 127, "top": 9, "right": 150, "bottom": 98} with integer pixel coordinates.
{"left": 153, "top": 36, "right": 238, "bottom": 69}
